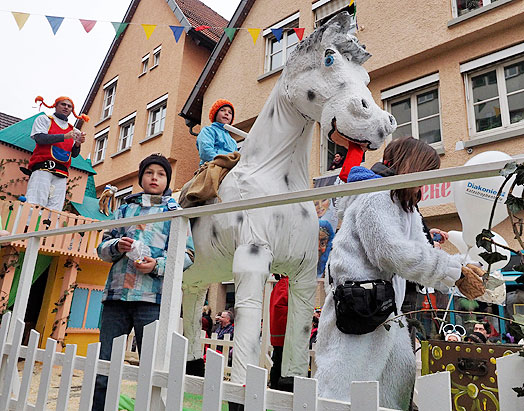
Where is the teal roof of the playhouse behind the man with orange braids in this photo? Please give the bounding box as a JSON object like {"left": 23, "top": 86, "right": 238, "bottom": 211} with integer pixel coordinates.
{"left": 0, "top": 113, "right": 96, "bottom": 174}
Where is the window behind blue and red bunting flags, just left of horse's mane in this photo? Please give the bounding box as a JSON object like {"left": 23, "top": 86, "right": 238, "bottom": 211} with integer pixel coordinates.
{"left": 263, "top": 13, "right": 299, "bottom": 72}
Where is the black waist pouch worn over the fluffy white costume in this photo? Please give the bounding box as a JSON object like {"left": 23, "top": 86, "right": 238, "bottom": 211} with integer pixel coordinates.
{"left": 333, "top": 280, "right": 397, "bottom": 335}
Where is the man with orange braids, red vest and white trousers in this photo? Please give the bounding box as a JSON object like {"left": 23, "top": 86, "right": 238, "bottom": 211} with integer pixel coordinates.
{"left": 26, "top": 96, "right": 89, "bottom": 211}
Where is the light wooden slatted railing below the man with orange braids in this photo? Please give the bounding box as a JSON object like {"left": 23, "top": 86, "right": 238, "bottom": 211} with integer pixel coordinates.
{"left": 0, "top": 200, "right": 102, "bottom": 259}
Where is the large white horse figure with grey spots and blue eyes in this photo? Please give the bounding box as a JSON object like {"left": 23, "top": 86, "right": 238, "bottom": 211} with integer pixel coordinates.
{"left": 183, "top": 13, "right": 395, "bottom": 383}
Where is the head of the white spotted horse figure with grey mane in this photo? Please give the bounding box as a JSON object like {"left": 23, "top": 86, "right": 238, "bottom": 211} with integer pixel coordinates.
{"left": 282, "top": 12, "right": 396, "bottom": 150}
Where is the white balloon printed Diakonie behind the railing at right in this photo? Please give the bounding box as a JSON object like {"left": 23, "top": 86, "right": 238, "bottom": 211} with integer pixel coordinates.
{"left": 452, "top": 151, "right": 516, "bottom": 247}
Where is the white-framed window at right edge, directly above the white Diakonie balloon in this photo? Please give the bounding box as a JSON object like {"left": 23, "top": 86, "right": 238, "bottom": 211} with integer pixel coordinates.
{"left": 466, "top": 56, "right": 524, "bottom": 136}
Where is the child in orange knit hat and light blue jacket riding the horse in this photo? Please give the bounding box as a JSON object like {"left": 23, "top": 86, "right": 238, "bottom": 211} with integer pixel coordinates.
{"left": 197, "top": 99, "right": 238, "bottom": 165}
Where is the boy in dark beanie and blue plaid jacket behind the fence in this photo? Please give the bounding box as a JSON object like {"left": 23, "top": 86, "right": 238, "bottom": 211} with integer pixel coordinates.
{"left": 93, "top": 154, "right": 194, "bottom": 410}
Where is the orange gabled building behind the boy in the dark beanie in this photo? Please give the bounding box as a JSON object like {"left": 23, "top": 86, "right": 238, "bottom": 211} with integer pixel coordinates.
{"left": 79, "top": 0, "right": 227, "bottom": 203}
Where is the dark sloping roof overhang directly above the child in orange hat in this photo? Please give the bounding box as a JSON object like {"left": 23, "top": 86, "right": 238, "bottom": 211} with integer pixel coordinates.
{"left": 179, "top": 0, "right": 255, "bottom": 124}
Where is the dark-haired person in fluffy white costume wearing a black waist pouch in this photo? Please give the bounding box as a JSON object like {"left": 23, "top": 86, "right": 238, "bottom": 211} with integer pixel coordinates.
{"left": 315, "top": 137, "right": 485, "bottom": 409}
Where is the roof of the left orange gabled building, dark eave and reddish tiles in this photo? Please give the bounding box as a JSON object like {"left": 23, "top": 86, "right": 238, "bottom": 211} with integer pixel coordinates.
{"left": 75, "top": 0, "right": 227, "bottom": 128}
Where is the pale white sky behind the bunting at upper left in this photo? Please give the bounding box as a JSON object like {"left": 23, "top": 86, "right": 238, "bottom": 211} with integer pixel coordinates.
{"left": 0, "top": 0, "right": 240, "bottom": 121}
